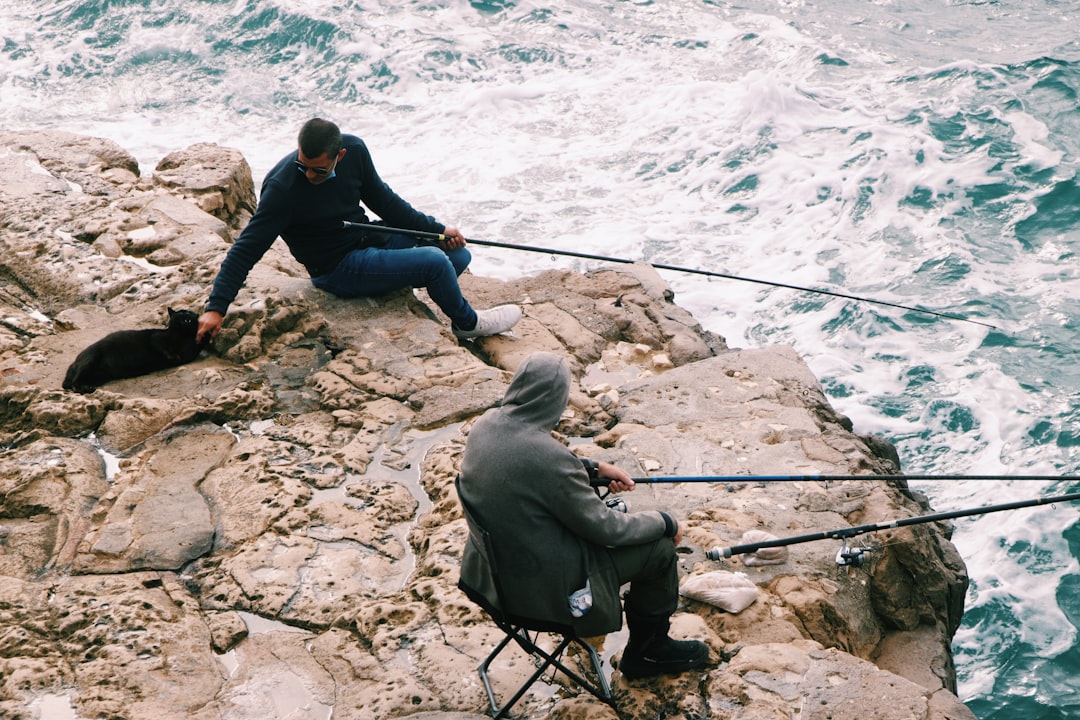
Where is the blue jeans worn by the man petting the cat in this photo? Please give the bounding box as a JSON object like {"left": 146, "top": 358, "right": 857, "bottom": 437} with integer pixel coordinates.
{"left": 311, "top": 235, "right": 476, "bottom": 330}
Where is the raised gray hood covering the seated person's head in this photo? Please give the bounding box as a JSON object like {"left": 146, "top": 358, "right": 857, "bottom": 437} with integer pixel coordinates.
{"left": 499, "top": 353, "right": 570, "bottom": 431}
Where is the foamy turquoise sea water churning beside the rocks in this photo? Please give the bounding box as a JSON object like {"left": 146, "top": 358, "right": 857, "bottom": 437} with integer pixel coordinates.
{"left": 0, "top": 0, "right": 1080, "bottom": 720}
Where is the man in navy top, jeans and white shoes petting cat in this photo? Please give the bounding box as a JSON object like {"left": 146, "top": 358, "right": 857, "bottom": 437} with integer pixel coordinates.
{"left": 198, "top": 118, "right": 522, "bottom": 340}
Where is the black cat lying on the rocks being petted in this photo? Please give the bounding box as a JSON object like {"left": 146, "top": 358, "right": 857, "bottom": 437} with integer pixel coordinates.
{"left": 64, "top": 308, "right": 208, "bottom": 393}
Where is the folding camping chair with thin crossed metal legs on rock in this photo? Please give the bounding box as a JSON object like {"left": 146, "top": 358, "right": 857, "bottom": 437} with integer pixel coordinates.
{"left": 458, "top": 481, "right": 615, "bottom": 720}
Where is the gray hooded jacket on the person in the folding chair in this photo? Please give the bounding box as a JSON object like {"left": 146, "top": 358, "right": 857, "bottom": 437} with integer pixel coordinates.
{"left": 459, "top": 353, "right": 670, "bottom": 637}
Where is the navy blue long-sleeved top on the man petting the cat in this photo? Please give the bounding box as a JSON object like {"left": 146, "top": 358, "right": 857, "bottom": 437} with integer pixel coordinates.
{"left": 206, "top": 135, "right": 446, "bottom": 315}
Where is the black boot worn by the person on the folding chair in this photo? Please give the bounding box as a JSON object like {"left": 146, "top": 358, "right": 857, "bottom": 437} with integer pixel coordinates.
{"left": 619, "top": 609, "right": 708, "bottom": 680}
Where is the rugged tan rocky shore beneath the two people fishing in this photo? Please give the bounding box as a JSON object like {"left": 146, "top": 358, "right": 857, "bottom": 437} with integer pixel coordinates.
{"left": 0, "top": 133, "right": 973, "bottom": 720}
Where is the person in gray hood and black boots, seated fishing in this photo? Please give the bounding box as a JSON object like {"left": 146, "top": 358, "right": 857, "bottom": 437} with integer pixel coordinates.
{"left": 459, "top": 353, "right": 708, "bottom": 678}
